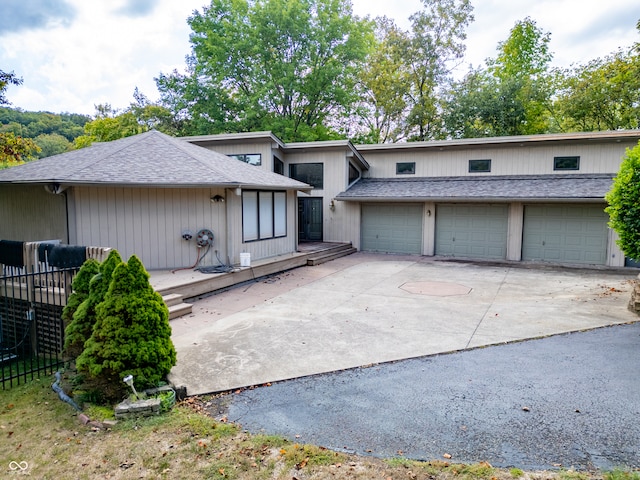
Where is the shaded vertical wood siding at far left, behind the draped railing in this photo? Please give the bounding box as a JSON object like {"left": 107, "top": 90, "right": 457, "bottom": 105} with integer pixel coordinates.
{"left": 0, "top": 185, "right": 68, "bottom": 243}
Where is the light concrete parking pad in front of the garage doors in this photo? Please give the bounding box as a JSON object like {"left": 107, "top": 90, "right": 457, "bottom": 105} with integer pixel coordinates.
{"left": 170, "top": 253, "right": 638, "bottom": 395}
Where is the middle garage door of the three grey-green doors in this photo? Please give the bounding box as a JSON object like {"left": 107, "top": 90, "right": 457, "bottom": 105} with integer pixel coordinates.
{"left": 435, "top": 204, "right": 508, "bottom": 259}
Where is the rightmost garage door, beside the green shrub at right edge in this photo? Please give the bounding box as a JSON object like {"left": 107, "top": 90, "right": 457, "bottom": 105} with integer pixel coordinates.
{"left": 522, "top": 205, "right": 608, "bottom": 265}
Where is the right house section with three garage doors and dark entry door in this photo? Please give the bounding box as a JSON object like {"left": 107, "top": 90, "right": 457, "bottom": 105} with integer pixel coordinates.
{"left": 185, "top": 130, "right": 640, "bottom": 267}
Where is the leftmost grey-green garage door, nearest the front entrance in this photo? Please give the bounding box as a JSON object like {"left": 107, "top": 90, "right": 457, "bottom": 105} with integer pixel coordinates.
{"left": 360, "top": 204, "right": 422, "bottom": 255}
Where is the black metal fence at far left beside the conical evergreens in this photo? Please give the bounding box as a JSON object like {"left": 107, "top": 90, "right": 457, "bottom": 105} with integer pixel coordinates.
{"left": 0, "top": 267, "right": 78, "bottom": 390}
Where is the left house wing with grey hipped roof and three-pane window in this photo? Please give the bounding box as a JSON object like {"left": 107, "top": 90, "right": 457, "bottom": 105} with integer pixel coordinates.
{"left": 0, "top": 131, "right": 310, "bottom": 270}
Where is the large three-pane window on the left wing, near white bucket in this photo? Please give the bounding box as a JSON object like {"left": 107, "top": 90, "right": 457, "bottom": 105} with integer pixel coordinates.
{"left": 242, "top": 190, "right": 287, "bottom": 242}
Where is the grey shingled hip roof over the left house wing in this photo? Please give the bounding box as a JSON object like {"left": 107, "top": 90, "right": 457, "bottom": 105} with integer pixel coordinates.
{"left": 0, "top": 131, "right": 311, "bottom": 190}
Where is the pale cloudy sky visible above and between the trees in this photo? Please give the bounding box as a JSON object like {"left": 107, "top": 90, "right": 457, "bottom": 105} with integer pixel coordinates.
{"left": 0, "top": 0, "right": 640, "bottom": 115}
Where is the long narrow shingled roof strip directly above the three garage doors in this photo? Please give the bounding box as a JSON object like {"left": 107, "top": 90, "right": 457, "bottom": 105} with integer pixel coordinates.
{"left": 336, "top": 174, "right": 614, "bottom": 202}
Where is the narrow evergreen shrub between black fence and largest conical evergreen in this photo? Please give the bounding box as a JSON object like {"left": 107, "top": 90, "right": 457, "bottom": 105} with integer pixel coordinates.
{"left": 62, "top": 250, "right": 122, "bottom": 359}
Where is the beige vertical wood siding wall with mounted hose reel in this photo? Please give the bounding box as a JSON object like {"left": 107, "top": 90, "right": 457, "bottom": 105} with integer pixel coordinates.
{"left": 74, "top": 187, "right": 227, "bottom": 270}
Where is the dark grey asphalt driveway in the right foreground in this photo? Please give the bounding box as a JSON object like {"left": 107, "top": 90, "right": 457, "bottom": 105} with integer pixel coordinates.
{"left": 220, "top": 323, "right": 640, "bottom": 470}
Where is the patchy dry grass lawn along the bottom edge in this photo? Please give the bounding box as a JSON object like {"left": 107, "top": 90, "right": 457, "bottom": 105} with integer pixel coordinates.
{"left": 0, "top": 379, "right": 640, "bottom": 480}
